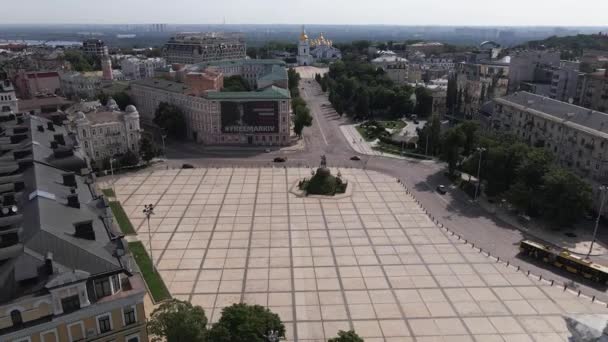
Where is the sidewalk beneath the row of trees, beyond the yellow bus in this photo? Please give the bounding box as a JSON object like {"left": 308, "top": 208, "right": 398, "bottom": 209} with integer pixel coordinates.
{"left": 478, "top": 196, "right": 608, "bottom": 256}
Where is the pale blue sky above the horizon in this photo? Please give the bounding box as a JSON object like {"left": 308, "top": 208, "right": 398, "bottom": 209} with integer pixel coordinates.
{"left": 0, "top": 0, "right": 608, "bottom": 26}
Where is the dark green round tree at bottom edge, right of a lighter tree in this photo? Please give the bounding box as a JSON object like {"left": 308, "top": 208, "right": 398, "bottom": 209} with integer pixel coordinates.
{"left": 209, "top": 304, "right": 285, "bottom": 342}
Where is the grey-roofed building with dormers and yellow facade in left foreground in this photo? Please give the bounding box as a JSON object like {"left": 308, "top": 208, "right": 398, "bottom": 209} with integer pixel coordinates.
{"left": 0, "top": 114, "right": 147, "bottom": 342}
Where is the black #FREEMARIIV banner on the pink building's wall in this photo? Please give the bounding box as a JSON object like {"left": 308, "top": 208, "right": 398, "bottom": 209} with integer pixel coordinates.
{"left": 221, "top": 101, "right": 279, "bottom": 133}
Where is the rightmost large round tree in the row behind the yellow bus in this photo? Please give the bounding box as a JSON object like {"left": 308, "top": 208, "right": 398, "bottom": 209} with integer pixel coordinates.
{"left": 540, "top": 168, "right": 592, "bottom": 226}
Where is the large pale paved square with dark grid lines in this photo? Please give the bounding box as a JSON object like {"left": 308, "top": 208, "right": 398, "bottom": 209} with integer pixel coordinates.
{"left": 115, "top": 168, "right": 607, "bottom": 342}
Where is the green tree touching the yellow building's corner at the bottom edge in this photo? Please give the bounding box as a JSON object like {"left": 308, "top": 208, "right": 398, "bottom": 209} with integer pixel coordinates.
{"left": 148, "top": 299, "right": 207, "bottom": 342}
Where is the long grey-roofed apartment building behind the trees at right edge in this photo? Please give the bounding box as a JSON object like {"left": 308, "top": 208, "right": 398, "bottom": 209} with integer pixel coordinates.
{"left": 489, "top": 92, "right": 608, "bottom": 210}
